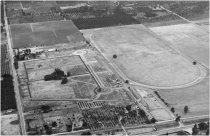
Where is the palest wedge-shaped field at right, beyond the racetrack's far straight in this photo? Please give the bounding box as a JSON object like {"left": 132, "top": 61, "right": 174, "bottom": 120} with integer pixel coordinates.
{"left": 150, "top": 24, "right": 209, "bottom": 68}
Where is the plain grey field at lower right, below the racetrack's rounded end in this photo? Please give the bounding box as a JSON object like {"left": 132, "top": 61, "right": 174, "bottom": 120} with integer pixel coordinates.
{"left": 158, "top": 79, "right": 209, "bottom": 117}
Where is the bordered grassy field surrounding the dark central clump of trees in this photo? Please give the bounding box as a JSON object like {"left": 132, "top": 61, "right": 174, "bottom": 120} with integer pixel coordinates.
{"left": 18, "top": 55, "right": 103, "bottom": 102}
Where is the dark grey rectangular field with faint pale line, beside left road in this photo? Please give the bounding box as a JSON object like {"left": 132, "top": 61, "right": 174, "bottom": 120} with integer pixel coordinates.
{"left": 10, "top": 21, "right": 84, "bottom": 48}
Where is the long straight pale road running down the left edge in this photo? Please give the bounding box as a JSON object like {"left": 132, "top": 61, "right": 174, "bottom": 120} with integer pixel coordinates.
{"left": 4, "top": 2, "right": 26, "bottom": 135}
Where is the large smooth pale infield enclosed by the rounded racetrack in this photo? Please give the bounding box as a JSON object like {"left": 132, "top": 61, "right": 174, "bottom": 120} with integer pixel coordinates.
{"left": 86, "top": 25, "right": 203, "bottom": 87}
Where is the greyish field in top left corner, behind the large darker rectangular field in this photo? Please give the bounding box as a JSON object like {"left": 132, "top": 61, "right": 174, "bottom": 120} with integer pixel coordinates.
{"left": 6, "top": 1, "right": 64, "bottom": 24}
